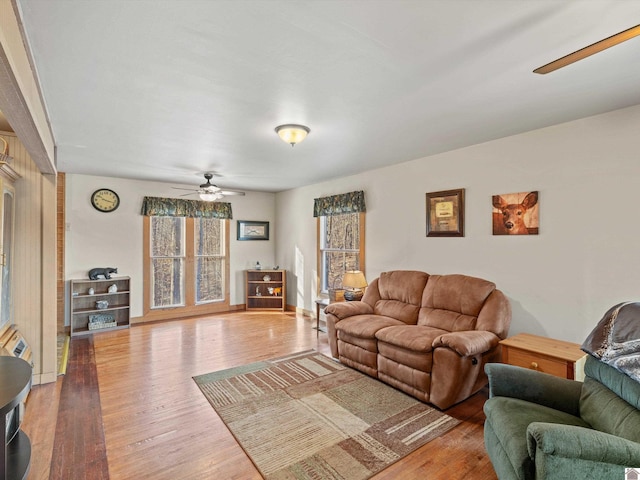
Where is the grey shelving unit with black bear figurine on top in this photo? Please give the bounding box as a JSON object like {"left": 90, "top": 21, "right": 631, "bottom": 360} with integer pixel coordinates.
{"left": 69, "top": 277, "right": 131, "bottom": 336}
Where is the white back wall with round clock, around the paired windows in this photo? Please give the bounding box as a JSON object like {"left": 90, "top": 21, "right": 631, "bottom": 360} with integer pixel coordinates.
{"left": 65, "top": 174, "right": 276, "bottom": 317}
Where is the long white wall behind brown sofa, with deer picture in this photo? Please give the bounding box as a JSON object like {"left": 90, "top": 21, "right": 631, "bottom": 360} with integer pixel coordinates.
{"left": 276, "top": 107, "right": 640, "bottom": 343}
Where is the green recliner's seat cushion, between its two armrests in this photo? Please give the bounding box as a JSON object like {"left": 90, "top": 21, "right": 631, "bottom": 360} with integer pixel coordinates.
{"left": 484, "top": 397, "right": 591, "bottom": 478}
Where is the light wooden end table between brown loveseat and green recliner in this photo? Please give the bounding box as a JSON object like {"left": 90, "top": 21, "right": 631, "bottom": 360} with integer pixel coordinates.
{"left": 500, "top": 333, "right": 586, "bottom": 380}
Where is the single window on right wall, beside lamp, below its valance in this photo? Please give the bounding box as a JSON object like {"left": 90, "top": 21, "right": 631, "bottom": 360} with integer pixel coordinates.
{"left": 318, "top": 213, "right": 365, "bottom": 293}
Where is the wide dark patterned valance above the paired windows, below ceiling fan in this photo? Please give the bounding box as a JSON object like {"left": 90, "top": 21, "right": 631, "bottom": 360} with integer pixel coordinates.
{"left": 140, "top": 197, "right": 233, "bottom": 219}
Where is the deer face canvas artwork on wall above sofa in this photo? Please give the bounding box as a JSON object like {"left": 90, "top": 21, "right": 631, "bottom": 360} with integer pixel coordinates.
{"left": 492, "top": 192, "right": 540, "bottom": 235}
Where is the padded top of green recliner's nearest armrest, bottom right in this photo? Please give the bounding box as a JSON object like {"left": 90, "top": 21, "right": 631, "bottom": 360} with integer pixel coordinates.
{"left": 527, "top": 422, "right": 640, "bottom": 466}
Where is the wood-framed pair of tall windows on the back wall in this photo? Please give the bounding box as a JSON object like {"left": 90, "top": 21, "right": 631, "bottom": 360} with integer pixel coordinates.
{"left": 144, "top": 216, "right": 229, "bottom": 319}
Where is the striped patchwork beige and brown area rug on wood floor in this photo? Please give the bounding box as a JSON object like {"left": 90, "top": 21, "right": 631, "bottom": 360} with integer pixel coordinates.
{"left": 194, "top": 351, "right": 459, "bottom": 480}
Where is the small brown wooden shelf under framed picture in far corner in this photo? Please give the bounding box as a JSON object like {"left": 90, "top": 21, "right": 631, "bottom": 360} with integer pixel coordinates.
{"left": 246, "top": 270, "right": 287, "bottom": 312}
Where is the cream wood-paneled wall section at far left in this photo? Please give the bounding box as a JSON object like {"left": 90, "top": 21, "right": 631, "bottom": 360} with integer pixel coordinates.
{"left": 0, "top": 132, "right": 57, "bottom": 384}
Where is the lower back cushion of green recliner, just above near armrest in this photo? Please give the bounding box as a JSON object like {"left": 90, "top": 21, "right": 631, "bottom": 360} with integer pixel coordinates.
{"left": 580, "top": 374, "right": 640, "bottom": 443}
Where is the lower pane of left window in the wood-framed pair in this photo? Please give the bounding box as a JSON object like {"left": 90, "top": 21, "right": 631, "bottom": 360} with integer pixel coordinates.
{"left": 151, "top": 258, "right": 184, "bottom": 308}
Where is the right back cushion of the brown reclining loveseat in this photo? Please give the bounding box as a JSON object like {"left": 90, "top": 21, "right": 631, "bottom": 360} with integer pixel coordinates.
{"left": 418, "top": 274, "right": 496, "bottom": 332}
